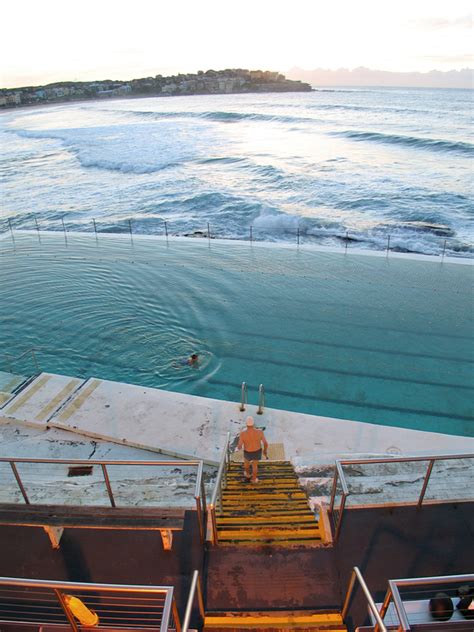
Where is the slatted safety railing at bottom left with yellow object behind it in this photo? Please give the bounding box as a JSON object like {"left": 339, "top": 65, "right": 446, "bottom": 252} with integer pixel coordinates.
{"left": 0, "top": 571, "right": 185, "bottom": 632}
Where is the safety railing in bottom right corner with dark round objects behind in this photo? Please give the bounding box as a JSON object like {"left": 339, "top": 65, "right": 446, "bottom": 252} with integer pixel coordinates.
{"left": 376, "top": 574, "right": 474, "bottom": 632}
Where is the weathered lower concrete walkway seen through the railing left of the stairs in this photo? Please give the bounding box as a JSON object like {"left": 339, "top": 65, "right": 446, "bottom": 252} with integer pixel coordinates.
{"left": 0, "top": 421, "right": 216, "bottom": 508}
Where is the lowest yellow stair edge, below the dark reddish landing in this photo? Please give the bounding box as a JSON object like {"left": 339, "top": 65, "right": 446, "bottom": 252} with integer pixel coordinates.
{"left": 203, "top": 610, "right": 347, "bottom": 632}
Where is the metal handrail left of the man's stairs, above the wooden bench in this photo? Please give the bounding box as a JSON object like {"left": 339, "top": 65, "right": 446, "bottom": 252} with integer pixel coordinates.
{"left": 0, "top": 457, "right": 207, "bottom": 543}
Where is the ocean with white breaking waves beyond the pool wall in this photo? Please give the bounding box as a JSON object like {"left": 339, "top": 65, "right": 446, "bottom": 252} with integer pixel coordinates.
{"left": 0, "top": 88, "right": 474, "bottom": 257}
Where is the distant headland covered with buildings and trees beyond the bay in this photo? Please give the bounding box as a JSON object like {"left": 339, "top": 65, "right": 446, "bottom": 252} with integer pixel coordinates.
{"left": 0, "top": 68, "right": 312, "bottom": 108}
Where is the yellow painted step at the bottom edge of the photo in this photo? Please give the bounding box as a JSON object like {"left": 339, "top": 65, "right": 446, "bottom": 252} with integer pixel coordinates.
{"left": 204, "top": 611, "right": 346, "bottom": 630}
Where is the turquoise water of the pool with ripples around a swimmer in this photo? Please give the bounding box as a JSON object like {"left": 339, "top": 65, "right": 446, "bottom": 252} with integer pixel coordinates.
{"left": 0, "top": 233, "right": 474, "bottom": 436}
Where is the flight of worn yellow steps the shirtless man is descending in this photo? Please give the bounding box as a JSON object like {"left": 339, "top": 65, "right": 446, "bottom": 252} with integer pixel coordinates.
{"left": 217, "top": 461, "right": 325, "bottom": 547}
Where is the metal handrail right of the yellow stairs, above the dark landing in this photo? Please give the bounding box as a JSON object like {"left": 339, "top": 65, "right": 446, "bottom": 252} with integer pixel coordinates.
{"left": 329, "top": 454, "right": 474, "bottom": 541}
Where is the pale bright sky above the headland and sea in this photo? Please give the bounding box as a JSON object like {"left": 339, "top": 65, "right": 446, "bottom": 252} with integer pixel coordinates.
{"left": 0, "top": 0, "right": 474, "bottom": 88}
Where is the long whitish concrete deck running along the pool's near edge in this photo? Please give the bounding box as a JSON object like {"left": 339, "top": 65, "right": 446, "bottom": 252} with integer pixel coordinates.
{"left": 0, "top": 373, "right": 474, "bottom": 466}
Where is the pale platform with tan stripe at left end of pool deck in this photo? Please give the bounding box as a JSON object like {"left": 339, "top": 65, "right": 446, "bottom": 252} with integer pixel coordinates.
{"left": 0, "top": 373, "right": 84, "bottom": 427}
